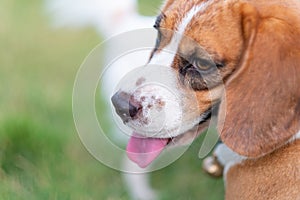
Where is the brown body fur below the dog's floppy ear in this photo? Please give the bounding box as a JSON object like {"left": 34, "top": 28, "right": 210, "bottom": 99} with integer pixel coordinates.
{"left": 226, "top": 140, "right": 300, "bottom": 200}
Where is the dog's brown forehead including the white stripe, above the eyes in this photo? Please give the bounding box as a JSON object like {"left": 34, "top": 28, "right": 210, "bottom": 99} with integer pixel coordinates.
{"left": 160, "top": 0, "right": 243, "bottom": 63}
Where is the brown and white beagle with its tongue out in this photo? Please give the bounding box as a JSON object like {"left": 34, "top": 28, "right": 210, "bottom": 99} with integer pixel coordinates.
{"left": 112, "top": 0, "right": 300, "bottom": 200}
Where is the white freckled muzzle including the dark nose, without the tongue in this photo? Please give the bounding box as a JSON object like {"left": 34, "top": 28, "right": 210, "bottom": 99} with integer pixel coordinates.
{"left": 111, "top": 65, "right": 202, "bottom": 138}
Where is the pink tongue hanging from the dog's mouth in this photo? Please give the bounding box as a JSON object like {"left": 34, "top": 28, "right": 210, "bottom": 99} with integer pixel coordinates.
{"left": 126, "top": 133, "right": 169, "bottom": 168}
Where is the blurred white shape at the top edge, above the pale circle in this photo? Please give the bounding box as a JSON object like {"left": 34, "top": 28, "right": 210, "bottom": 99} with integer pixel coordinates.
{"left": 46, "top": 0, "right": 154, "bottom": 38}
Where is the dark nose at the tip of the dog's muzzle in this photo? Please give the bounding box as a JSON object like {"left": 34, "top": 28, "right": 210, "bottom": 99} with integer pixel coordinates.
{"left": 111, "top": 92, "right": 140, "bottom": 123}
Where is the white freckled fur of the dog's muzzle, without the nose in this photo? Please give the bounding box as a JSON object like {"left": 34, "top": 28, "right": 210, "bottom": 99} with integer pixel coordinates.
{"left": 127, "top": 65, "right": 202, "bottom": 138}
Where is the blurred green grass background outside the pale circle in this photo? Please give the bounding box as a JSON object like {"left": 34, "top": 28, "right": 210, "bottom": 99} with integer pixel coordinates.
{"left": 0, "top": 0, "right": 224, "bottom": 200}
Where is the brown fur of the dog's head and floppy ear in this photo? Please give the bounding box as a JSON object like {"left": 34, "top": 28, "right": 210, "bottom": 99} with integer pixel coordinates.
{"left": 161, "top": 0, "right": 300, "bottom": 157}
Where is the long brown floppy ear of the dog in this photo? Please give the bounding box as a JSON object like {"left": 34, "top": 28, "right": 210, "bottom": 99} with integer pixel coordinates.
{"left": 218, "top": 3, "right": 300, "bottom": 157}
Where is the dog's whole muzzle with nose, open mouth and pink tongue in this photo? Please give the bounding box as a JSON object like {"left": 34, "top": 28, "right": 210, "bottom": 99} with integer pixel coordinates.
{"left": 111, "top": 71, "right": 216, "bottom": 168}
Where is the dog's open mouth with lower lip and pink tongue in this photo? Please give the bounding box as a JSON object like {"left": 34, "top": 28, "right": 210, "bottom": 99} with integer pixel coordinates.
{"left": 126, "top": 109, "right": 212, "bottom": 168}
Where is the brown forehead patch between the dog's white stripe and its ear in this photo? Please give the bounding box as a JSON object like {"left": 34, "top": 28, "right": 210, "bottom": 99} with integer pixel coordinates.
{"left": 184, "top": 1, "right": 243, "bottom": 60}
